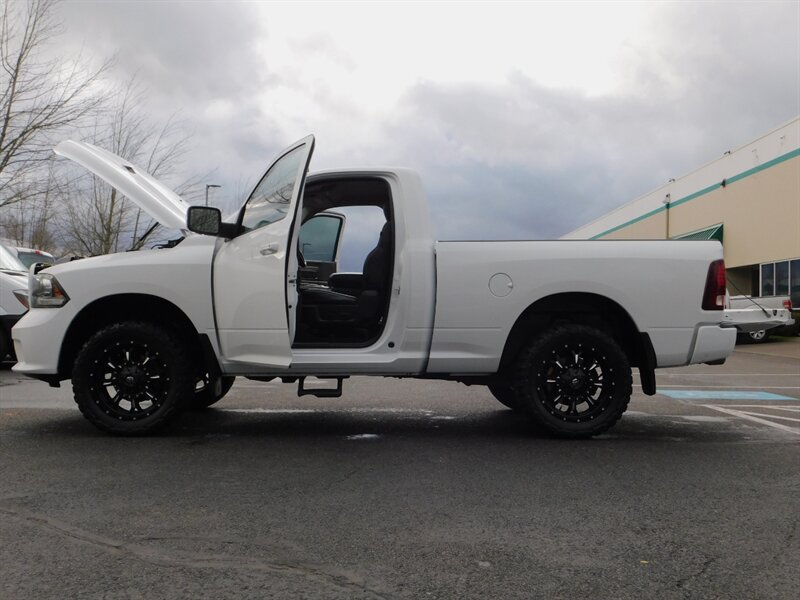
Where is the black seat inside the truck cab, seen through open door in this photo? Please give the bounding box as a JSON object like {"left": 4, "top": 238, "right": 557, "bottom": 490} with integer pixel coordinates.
{"left": 299, "top": 223, "right": 392, "bottom": 322}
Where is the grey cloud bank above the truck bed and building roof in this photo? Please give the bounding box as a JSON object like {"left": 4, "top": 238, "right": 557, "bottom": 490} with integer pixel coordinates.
{"left": 376, "top": 4, "right": 800, "bottom": 239}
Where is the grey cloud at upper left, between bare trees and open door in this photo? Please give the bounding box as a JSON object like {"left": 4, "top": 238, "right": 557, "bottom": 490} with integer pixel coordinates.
{"left": 54, "top": 2, "right": 281, "bottom": 209}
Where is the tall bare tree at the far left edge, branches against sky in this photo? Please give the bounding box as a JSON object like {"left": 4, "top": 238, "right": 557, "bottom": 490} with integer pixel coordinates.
{"left": 0, "top": 0, "right": 111, "bottom": 207}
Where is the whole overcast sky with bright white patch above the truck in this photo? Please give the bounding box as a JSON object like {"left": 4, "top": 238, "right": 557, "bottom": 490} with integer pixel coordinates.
{"left": 54, "top": 1, "right": 800, "bottom": 247}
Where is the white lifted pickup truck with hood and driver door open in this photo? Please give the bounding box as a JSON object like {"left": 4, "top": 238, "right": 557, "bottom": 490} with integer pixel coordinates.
{"left": 13, "top": 137, "right": 736, "bottom": 437}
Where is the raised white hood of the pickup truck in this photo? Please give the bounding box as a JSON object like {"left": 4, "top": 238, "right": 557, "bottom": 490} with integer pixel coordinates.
{"left": 53, "top": 140, "right": 189, "bottom": 229}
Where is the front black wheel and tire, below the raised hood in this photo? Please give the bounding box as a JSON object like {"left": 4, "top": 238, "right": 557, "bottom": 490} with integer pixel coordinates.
{"left": 72, "top": 321, "right": 194, "bottom": 435}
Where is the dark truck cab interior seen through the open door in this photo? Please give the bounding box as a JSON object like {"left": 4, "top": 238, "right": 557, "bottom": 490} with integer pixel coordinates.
{"left": 292, "top": 177, "right": 394, "bottom": 348}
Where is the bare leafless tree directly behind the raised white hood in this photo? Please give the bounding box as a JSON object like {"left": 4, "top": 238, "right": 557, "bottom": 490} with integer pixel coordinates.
{"left": 60, "top": 77, "right": 191, "bottom": 255}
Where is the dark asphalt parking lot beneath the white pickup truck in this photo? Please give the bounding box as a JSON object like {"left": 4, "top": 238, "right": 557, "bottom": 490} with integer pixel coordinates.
{"left": 0, "top": 338, "right": 800, "bottom": 599}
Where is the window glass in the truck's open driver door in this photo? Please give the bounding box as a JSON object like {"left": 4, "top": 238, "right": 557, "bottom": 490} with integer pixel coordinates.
{"left": 242, "top": 146, "right": 306, "bottom": 229}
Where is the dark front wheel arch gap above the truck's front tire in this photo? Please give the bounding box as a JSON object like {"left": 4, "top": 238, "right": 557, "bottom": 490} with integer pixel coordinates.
{"left": 58, "top": 293, "right": 219, "bottom": 378}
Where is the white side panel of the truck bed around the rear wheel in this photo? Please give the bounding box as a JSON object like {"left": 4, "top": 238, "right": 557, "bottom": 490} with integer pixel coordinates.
{"left": 428, "top": 241, "right": 735, "bottom": 373}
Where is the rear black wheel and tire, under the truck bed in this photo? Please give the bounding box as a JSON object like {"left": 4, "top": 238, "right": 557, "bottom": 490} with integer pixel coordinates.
{"left": 513, "top": 324, "right": 632, "bottom": 438}
